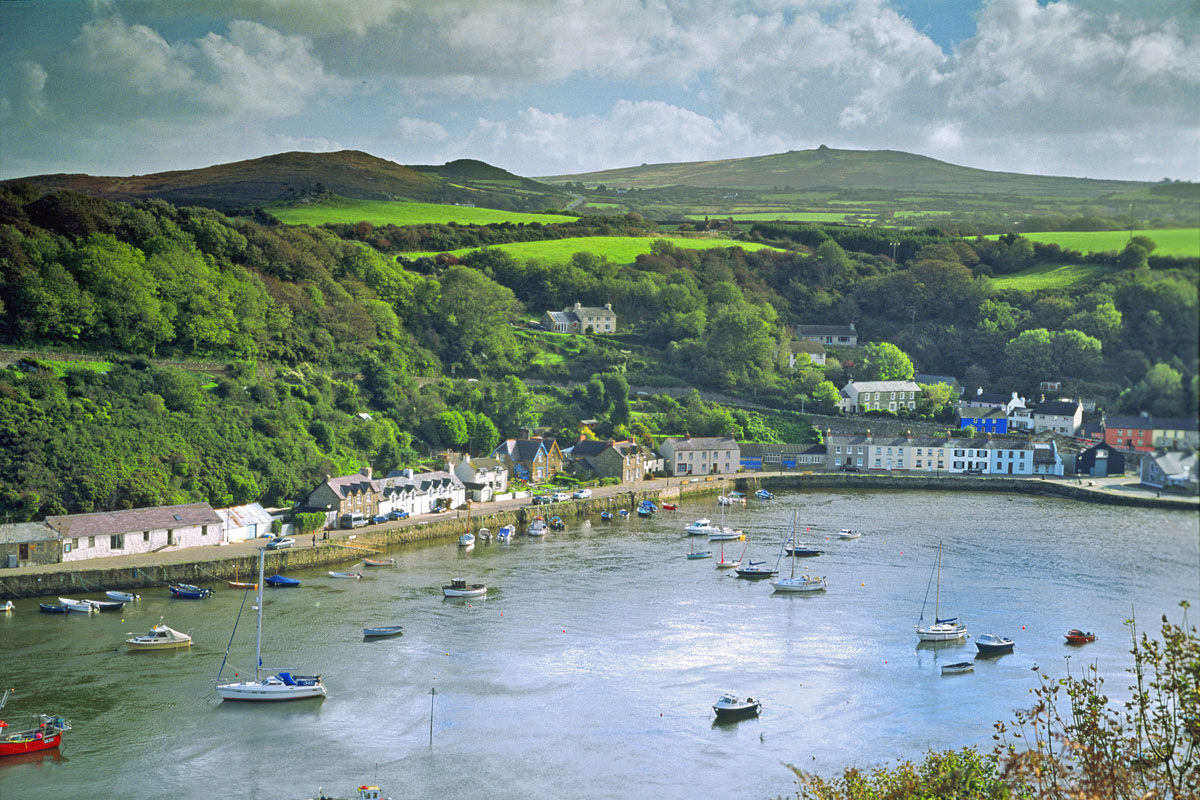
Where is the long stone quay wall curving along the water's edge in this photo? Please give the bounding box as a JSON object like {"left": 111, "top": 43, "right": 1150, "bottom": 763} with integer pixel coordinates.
{"left": 0, "top": 471, "right": 1185, "bottom": 600}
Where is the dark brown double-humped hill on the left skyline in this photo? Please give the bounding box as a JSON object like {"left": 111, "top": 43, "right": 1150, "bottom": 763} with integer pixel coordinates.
{"left": 0, "top": 150, "right": 568, "bottom": 211}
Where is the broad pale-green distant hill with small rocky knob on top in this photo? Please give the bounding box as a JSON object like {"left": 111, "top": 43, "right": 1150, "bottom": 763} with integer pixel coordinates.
{"left": 540, "top": 145, "right": 1151, "bottom": 198}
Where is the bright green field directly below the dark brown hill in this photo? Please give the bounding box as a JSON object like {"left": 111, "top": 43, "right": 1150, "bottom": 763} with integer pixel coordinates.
{"left": 266, "top": 198, "right": 577, "bottom": 225}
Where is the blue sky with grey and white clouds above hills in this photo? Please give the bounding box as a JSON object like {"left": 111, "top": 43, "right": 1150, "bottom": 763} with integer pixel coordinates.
{"left": 0, "top": 0, "right": 1200, "bottom": 180}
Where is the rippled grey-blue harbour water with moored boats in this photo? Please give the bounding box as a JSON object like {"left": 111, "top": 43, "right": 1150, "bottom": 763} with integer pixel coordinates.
{"left": 0, "top": 492, "right": 1200, "bottom": 800}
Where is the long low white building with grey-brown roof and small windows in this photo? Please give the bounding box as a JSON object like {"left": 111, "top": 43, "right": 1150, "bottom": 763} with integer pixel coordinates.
{"left": 46, "top": 503, "right": 224, "bottom": 561}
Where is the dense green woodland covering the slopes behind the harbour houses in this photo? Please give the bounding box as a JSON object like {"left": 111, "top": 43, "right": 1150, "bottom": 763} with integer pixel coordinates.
{"left": 0, "top": 185, "right": 1198, "bottom": 519}
